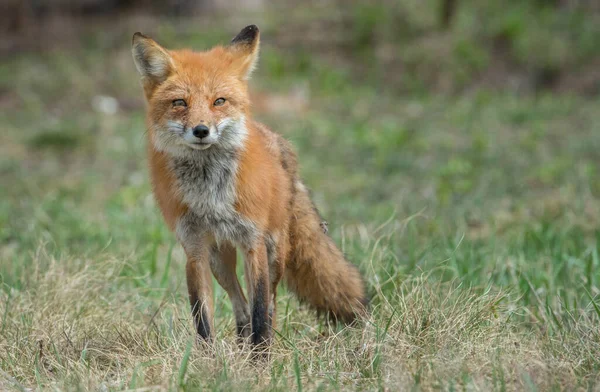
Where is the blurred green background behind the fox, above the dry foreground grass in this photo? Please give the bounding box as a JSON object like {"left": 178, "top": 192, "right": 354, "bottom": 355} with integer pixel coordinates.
{"left": 0, "top": 0, "right": 600, "bottom": 388}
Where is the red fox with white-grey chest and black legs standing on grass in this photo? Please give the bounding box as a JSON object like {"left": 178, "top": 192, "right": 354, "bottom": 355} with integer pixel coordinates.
{"left": 132, "top": 25, "right": 367, "bottom": 345}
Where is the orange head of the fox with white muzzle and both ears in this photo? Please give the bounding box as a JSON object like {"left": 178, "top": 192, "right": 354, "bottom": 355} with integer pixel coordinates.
{"left": 132, "top": 25, "right": 260, "bottom": 155}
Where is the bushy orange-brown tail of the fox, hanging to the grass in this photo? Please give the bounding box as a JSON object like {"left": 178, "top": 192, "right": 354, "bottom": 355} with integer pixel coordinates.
{"left": 285, "top": 182, "right": 368, "bottom": 323}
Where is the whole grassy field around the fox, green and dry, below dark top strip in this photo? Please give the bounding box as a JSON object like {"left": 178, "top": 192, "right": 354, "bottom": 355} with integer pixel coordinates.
{"left": 0, "top": 4, "right": 600, "bottom": 391}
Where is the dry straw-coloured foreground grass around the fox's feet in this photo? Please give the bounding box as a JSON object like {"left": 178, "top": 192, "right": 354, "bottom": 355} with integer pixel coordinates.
{"left": 0, "top": 242, "right": 600, "bottom": 390}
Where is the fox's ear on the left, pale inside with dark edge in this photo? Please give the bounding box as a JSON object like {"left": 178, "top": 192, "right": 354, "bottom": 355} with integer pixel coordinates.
{"left": 131, "top": 33, "right": 173, "bottom": 83}
